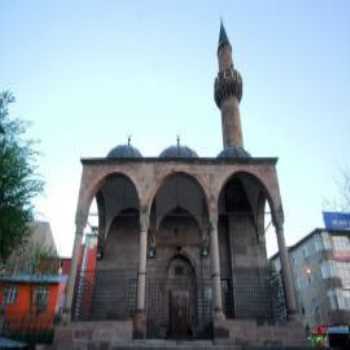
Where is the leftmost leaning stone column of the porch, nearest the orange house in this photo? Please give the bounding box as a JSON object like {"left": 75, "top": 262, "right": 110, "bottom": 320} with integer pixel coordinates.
{"left": 64, "top": 223, "right": 85, "bottom": 322}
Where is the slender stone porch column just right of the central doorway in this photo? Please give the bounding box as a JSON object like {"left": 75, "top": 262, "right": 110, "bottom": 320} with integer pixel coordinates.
{"left": 210, "top": 214, "right": 225, "bottom": 319}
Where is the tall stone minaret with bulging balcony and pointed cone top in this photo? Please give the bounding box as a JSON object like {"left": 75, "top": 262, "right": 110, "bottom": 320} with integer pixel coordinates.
{"left": 214, "top": 22, "right": 243, "bottom": 149}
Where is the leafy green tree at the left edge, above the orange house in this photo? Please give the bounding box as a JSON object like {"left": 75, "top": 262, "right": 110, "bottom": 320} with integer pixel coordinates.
{"left": 0, "top": 91, "right": 43, "bottom": 265}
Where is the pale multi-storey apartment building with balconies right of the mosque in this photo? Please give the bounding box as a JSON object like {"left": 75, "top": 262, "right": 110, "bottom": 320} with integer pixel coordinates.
{"left": 271, "top": 228, "right": 350, "bottom": 330}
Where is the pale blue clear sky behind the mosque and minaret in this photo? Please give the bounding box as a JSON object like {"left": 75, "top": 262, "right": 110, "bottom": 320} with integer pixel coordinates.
{"left": 0, "top": 0, "right": 350, "bottom": 256}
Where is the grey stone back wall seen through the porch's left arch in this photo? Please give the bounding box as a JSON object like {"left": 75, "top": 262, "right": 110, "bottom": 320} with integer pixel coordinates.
{"left": 91, "top": 214, "right": 139, "bottom": 320}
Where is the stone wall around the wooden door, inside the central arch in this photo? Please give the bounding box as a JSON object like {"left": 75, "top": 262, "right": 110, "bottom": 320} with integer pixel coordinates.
{"left": 146, "top": 214, "right": 212, "bottom": 338}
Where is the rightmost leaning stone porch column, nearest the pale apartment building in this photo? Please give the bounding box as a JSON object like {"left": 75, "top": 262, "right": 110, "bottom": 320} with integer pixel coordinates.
{"left": 275, "top": 221, "right": 297, "bottom": 319}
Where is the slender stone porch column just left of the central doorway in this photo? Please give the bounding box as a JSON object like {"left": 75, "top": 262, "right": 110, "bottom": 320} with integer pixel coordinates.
{"left": 134, "top": 209, "right": 149, "bottom": 338}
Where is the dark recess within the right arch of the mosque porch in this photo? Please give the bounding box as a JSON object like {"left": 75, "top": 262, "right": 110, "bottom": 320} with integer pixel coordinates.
{"left": 217, "top": 171, "right": 279, "bottom": 319}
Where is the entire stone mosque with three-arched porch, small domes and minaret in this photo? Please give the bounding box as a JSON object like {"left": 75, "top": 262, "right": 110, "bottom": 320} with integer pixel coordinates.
{"left": 60, "top": 24, "right": 302, "bottom": 345}
